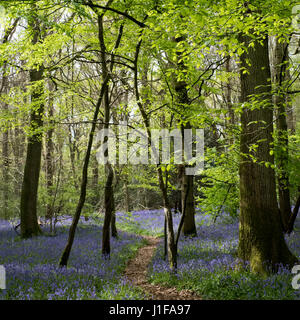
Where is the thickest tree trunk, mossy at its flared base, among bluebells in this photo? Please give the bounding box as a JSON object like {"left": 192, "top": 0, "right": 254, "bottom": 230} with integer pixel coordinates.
{"left": 238, "top": 36, "right": 297, "bottom": 274}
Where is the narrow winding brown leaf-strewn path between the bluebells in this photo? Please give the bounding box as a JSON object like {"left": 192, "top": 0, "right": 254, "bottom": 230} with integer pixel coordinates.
{"left": 125, "top": 236, "right": 201, "bottom": 300}
